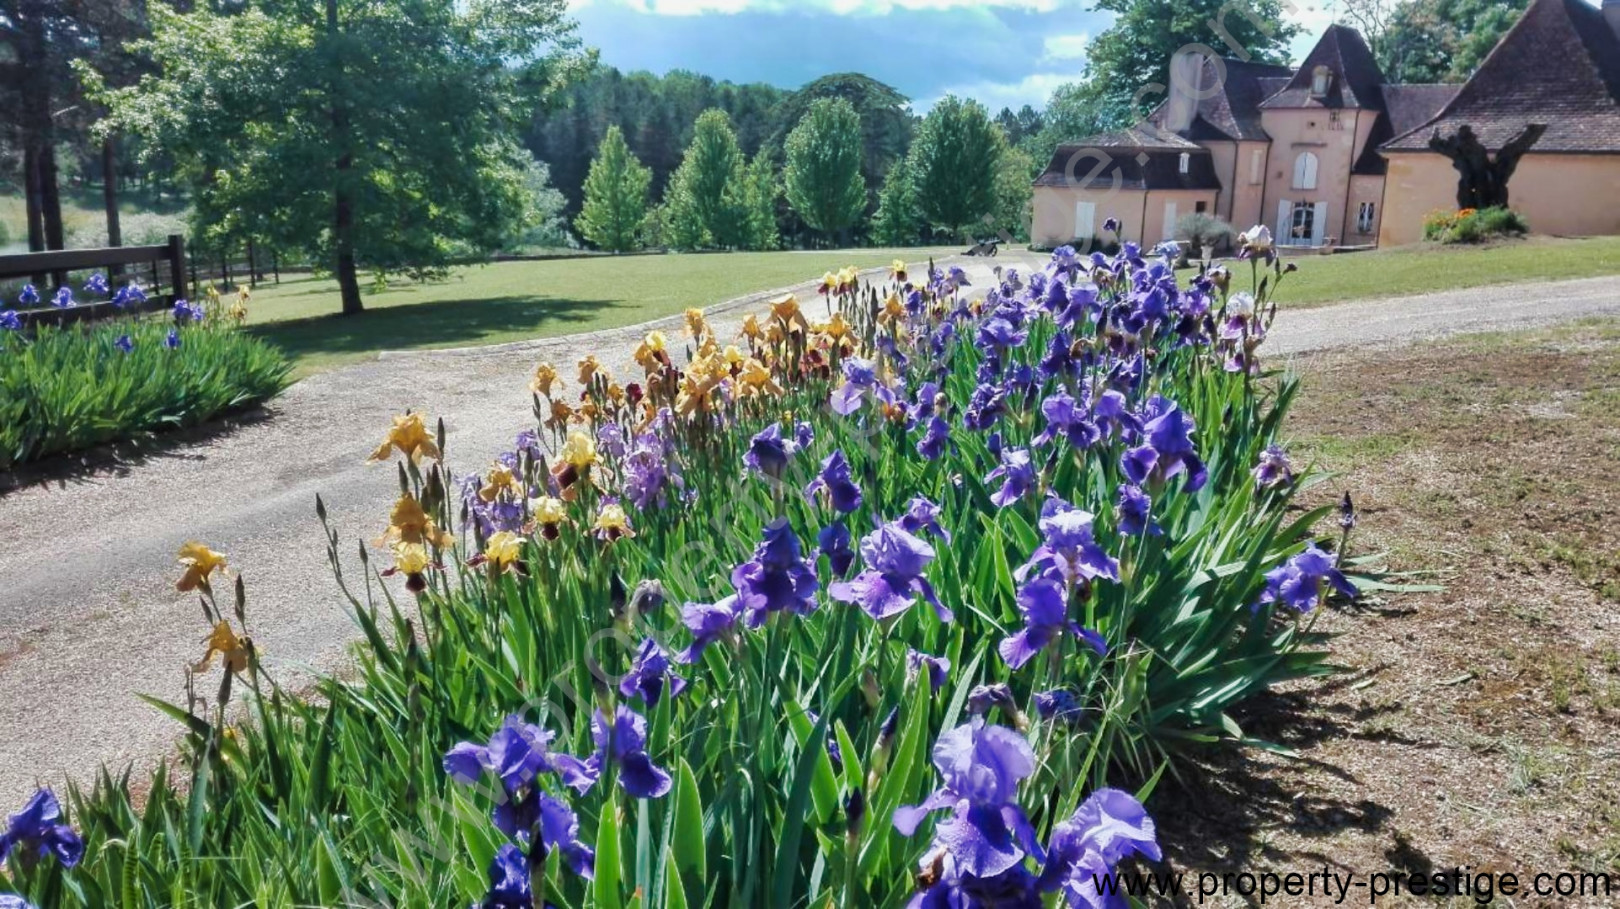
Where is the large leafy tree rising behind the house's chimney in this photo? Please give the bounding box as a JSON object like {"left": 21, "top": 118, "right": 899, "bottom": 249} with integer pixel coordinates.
{"left": 1072, "top": 0, "right": 1299, "bottom": 121}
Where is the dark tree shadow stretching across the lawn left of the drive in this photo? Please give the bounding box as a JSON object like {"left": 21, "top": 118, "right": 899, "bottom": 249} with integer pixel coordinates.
{"left": 246, "top": 295, "right": 632, "bottom": 358}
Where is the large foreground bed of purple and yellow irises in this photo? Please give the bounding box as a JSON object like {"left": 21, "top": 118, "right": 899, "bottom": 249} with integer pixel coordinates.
{"left": 0, "top": 228, "right": 1366, "bottom": 907}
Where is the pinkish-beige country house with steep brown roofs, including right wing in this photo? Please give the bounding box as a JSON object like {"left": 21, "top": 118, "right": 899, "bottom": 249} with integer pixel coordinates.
{"left": 1030, "top": 0, "right": 1620, "bottom": 248}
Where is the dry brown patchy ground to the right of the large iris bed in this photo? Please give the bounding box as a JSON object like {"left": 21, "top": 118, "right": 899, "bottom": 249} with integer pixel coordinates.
{"left": 1158, "top": 319, "right": 1620, "bottom": 906}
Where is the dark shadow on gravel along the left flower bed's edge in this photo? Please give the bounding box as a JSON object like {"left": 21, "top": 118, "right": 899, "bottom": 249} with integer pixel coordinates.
{"left": 0, "top": 405, "right": 274, "bottom": 504}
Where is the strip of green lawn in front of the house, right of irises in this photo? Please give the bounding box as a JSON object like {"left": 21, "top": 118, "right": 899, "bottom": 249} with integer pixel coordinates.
{"left": 1233, "top": 237, "right": 1620, "bottom": 306}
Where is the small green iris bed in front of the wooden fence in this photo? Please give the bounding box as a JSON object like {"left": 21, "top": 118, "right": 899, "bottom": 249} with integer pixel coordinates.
{"left": 0, "top": 275, "right": 287, "bottom": 470}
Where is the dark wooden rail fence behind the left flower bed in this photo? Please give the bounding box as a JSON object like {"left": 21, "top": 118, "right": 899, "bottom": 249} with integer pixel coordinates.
{"left": 0, "top": 233, "right": 186, "bottom": 326}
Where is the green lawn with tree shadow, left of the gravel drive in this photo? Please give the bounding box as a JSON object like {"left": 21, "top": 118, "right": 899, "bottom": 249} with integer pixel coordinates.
{"left": 248, "top": 248, "right": 961, "bottom": 376}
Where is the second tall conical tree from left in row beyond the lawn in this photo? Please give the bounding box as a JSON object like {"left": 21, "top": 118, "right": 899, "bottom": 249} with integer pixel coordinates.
{"left": 664, "top": 109, "right": 745, "bottom": 250}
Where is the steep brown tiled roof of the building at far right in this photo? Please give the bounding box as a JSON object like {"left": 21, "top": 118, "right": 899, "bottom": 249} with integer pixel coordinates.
{"left": 1383, "top": 0, "right": 1620, "bottom": 152}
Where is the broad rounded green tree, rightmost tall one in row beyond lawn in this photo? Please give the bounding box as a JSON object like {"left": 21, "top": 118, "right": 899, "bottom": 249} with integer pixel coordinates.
{"left": 910, "top": 96, "right": 1006, "bottom": 237}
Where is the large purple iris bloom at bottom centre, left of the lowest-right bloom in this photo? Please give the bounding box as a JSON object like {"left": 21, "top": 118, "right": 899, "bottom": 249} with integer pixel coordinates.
{"left": 894, "top": 716, "right": 1045, "bottom": 878}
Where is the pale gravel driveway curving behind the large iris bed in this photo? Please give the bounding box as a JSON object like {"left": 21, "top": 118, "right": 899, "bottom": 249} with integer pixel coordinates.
{"left": 0, "top": 254, "right": 1620, "bottom": 800}
